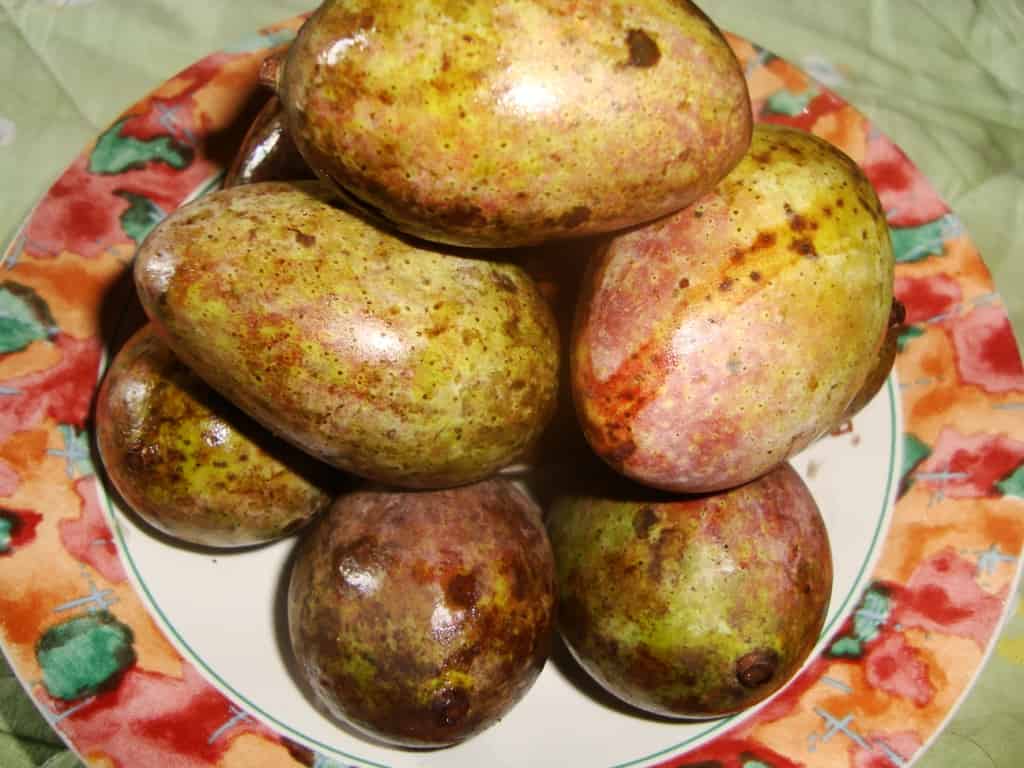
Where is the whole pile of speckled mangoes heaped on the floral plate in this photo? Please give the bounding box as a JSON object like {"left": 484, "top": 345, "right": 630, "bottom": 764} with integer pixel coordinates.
{"left": 97, "top": 0, "right": 898, "bottom": 746}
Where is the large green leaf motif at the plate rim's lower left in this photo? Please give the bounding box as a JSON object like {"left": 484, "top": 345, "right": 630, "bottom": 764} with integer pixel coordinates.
{"left": 36, "top": 611, "right": 135, "bottom": 700}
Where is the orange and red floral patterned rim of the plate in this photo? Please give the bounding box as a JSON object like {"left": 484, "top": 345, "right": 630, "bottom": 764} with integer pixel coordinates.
{"left": 0, "top": 19, "right": 1024, "bottom": 768}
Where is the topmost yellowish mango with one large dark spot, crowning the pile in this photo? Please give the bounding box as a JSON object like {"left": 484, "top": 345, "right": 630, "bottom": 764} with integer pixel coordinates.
{"left": 279, "top": 0, "right": 752, "bottom": 247}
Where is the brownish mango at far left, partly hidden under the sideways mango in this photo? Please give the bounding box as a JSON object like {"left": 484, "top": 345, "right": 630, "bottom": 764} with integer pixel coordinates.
{"left": 95, "top": 326, "right": 341, "bottom": 548}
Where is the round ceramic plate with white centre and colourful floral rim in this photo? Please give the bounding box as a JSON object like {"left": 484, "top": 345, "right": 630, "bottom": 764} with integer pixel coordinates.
{"left": 0, "top": 19, "right": 1024, "bottom": 768}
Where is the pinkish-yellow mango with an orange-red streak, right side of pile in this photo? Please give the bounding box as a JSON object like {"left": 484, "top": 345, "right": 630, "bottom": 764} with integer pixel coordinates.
{"left": 570, "top": 125, "right": 893, "bottom": 493}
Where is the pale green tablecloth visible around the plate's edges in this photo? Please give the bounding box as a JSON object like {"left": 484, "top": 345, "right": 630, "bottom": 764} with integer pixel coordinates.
{"left": 0, "top": 0, "right": 1024, "bottom": 768}
